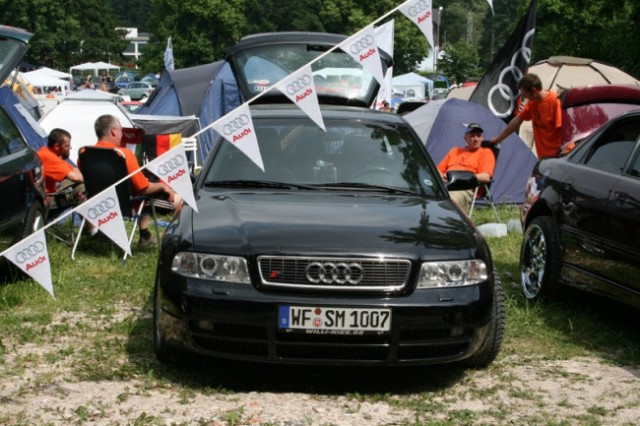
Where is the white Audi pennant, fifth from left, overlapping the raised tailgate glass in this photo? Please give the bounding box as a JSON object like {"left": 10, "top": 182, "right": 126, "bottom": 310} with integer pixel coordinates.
{"left": 276, "top": 65, "right": 326, "bottom": 130}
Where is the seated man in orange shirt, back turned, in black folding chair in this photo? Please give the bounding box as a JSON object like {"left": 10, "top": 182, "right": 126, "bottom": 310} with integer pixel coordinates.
{"left": 94, "top": 114, "right": 181, "bottom": 246}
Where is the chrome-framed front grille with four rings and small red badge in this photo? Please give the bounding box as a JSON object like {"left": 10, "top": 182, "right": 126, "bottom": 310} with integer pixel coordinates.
{"left": 258, "top": 256, "right": 411, "bottom": 292}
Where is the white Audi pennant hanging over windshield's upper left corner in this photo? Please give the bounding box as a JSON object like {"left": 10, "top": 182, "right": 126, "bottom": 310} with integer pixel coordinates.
{"left": 213, "top": 104, "right": 264, "bottom": 171}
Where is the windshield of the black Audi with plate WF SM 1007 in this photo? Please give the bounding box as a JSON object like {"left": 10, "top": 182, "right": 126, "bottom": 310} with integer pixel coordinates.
{"left": 204, "top": 119, "right": 441, "bottom": 196}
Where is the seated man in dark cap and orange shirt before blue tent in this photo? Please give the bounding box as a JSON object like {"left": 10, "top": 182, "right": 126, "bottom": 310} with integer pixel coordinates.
{"left": 438, "top": 123, "right": 496, "bottom": 212}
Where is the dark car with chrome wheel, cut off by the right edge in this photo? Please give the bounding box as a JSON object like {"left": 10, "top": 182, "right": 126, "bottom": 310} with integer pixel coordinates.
{"left": 520, "top": 106, "right": 640, "bottom": 307}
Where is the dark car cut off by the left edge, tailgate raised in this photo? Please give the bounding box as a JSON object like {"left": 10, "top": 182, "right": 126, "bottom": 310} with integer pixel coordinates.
{"left": 0, "top": 26, "right": 44, "bottom": 253}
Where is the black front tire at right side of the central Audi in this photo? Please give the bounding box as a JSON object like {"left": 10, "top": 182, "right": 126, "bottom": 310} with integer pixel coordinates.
{"left": 464, "top": 272, "right": 505, "bottom": 368}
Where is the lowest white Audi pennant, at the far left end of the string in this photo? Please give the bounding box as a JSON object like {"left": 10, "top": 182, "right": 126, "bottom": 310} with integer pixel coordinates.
{"left": 4, "top": 230, "right": 56, "bottom": 299}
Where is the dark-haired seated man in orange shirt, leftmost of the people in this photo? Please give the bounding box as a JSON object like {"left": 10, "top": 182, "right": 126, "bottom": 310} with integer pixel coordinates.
{"left": 36, "top": 129, "right": 84, "bottom": 209}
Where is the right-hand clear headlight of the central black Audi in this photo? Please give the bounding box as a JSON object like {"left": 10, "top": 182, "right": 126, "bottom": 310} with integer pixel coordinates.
{"left": 418, "top": 259, "right": 487, "bottom": 288}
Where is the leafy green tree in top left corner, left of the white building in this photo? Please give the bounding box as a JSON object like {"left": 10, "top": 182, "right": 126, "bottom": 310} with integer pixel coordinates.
{"left": 0, "top": 0, "right": 127, "bottom": 69}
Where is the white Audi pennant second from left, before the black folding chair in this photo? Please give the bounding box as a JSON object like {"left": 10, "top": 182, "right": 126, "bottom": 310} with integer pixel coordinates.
{"left": 76, "top": 186, "right": 131, "bottom": 256}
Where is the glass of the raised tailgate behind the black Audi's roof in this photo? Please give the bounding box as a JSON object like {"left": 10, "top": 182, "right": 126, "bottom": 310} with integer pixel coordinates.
{"left": 233, "top": 44, "right": 377, "bottom": 103}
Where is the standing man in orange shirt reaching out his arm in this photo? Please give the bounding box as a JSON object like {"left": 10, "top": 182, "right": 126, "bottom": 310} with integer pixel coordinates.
{"left": 489, "top": 74, "right": 562, "bottom": 159}
